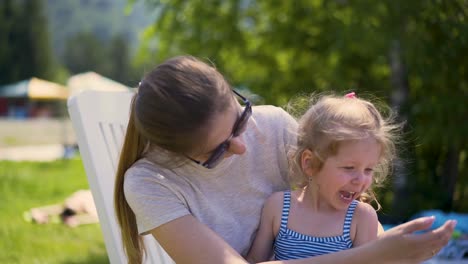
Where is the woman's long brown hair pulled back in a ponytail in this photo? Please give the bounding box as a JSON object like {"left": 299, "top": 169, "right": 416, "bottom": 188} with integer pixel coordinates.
{"left": 114, "top": 56, "right": 235, "bottom": 263}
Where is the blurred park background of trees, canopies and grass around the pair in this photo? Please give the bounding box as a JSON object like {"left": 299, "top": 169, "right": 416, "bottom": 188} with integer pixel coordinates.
{"left": 0, "top": 0, "right": 468, "bottom": 263}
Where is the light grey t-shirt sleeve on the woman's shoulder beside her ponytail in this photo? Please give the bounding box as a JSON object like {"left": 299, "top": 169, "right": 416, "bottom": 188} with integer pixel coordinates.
{"left": 124, "top": 166, "right": 190, "bottom": 235}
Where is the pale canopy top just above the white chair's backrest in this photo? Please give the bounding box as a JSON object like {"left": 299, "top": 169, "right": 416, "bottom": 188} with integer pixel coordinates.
{"left": 67, "top": 72, "right": 130, "bottom": 95}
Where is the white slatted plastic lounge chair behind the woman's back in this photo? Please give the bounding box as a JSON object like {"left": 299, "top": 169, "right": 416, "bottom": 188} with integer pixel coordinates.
{"left": 68, "top": 90, "right": 174, "bottom": 264}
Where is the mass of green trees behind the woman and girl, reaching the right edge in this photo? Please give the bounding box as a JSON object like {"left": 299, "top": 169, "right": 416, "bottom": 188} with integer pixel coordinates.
{"left": 137, "top": 0, "right": 468, "bottom": 218}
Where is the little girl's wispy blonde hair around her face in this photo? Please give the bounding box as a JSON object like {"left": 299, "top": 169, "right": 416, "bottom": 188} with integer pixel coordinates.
{"left": 290, "top": 92, "right": 400, "bottom": 209}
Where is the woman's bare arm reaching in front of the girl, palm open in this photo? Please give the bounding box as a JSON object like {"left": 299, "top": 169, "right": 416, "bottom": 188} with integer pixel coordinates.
{"left": 151, "top": 216, "right": 456, "bottom": 264}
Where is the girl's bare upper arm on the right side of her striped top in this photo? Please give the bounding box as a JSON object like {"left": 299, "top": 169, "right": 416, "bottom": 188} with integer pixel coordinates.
{"left": 353, "top": 202, "right": 379, "bottom": 247}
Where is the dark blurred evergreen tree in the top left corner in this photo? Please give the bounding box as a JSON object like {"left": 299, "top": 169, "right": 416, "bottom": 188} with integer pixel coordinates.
{"left": 0, "top": 0, "right": 54, "bottom": 84}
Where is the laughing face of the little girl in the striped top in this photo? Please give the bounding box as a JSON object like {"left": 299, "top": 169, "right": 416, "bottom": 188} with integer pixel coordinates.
{"left": 311, "top": 137, "right": 382, "bottom": 210}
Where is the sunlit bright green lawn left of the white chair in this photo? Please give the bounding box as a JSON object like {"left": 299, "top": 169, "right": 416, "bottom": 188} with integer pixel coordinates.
{"left": 0, "top": 158, "right": 109, "bottom": 264}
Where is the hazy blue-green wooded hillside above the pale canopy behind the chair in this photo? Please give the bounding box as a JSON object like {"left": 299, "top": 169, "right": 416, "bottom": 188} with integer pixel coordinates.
{"left": 47, "top": 0, "right": 151, "bottom": 86}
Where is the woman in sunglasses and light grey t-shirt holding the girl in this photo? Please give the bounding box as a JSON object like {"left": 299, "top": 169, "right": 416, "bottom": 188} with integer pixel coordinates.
{"left": 114, "top": 56, "right": 455, "bottom": 263}
